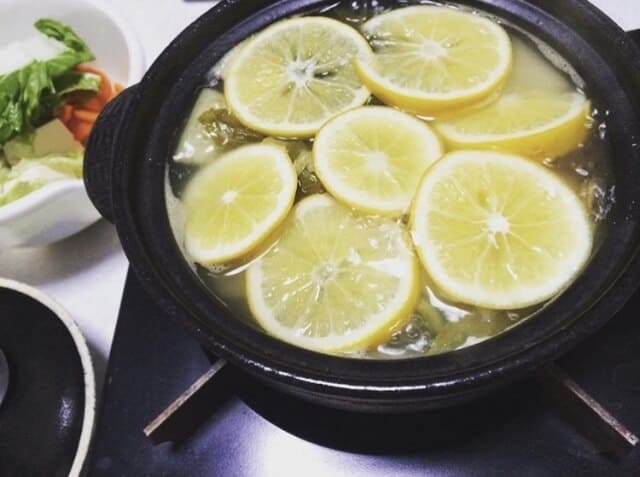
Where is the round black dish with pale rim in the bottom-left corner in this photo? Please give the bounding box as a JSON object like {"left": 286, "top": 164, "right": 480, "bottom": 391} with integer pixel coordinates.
{"left": 0, "top": 279, "right": 96, "bottom": 477}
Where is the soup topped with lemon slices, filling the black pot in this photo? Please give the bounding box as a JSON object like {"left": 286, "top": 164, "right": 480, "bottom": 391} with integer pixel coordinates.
{"left": 167, "top": 1, "right": 614, "bottom": 358}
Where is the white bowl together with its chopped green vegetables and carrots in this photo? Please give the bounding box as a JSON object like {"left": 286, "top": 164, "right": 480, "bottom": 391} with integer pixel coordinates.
{"left": 0, "top": 2, "right": 144, "bottom": 247}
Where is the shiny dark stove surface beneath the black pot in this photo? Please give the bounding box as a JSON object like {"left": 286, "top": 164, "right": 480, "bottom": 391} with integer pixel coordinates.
{"left": 88, "top": 266, "right": 640, "bottom": 477}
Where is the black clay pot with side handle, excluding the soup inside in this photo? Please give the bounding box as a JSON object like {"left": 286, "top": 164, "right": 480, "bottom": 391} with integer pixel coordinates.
{"left": 85, "top": 0, "right": 640, "bottom": 413}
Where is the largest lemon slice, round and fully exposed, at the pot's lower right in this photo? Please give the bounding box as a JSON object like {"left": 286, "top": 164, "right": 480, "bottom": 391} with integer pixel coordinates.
{"left": 411, "top": 151, "right": 593, "bottom": 310}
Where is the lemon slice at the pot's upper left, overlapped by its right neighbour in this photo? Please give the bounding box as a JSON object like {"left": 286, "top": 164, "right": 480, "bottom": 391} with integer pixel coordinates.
{"left": 224, "top": 17, "right": 372, "bottom": 137}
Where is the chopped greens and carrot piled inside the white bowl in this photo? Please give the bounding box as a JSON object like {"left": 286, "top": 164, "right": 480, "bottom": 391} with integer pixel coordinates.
{"left": 0, "top": 19, "right": 117, "bottom": 206}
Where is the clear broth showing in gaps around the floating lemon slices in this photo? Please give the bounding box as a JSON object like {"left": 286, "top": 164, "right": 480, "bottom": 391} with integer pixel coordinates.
{"left": 167, "top": 0, "right": 615, "bottom": 359}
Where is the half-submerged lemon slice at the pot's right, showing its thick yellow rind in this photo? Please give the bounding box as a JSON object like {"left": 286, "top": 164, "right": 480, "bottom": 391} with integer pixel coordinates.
{"left": 434, "top": 90, "right": 591, "bottom": 159}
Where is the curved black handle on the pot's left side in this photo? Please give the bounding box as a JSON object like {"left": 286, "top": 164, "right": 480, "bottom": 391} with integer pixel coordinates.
{"left": 83, "top": 85, "right": 137, "bottom": 222}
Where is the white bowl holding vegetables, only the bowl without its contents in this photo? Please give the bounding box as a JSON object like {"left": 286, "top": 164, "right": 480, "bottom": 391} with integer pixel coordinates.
{"left": 0, "top": 0, "right": 145, "bottom": 248}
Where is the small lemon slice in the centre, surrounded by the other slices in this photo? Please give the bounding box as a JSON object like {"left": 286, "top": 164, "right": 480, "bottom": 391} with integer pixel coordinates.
{"left": 313, "top": 106, "right": 443, "bottom": 215}
